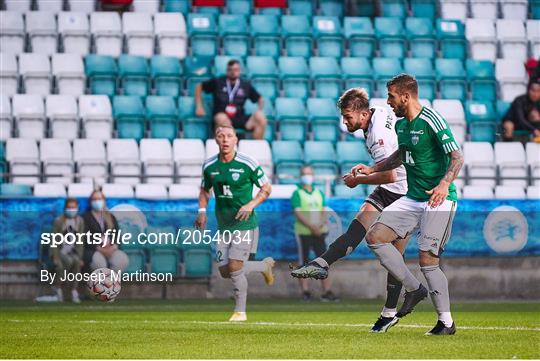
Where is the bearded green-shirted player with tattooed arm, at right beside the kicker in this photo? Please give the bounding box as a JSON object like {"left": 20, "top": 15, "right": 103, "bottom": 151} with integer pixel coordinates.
{"left": 354, "top": 74, "right": 463, "bottom": 335}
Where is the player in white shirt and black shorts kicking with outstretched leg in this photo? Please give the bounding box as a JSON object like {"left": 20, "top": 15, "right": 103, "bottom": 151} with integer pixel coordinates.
{"left": 291, "top": 88, "right": 407, "bottom": 332}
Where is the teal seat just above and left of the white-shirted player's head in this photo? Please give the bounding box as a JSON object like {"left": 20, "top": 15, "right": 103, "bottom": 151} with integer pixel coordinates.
{"left": 309, "top": 57, "right": 342, "bottom": 99}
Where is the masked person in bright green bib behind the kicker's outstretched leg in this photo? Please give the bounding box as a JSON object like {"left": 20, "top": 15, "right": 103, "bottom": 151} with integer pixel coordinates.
{"left": 291, "top": 166, "right": 338, "bottom": 301}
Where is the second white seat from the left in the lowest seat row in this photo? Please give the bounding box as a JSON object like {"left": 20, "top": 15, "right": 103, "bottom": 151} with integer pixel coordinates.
{"left": 39, "top": 138, "right": 73, "bottom": 185}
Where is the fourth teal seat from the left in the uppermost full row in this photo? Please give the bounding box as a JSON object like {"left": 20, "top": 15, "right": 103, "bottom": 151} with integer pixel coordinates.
{"left": 281, "top": 15, "right": 312, "bottom": 58}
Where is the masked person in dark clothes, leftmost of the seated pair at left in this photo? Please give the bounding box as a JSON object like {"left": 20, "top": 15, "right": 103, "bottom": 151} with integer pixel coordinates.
{"left": 50, "top": 198, "right": 84, "bottom": 303}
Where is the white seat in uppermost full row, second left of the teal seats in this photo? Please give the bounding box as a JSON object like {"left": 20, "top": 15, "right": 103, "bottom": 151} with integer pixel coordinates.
{"left": 122, "top": 12, "right": 154, "bottom": 58}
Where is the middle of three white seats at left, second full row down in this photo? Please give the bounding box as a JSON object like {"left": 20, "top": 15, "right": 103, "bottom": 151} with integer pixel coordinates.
{"left": 19, "top": 53, "right": 52, "bottom": 95}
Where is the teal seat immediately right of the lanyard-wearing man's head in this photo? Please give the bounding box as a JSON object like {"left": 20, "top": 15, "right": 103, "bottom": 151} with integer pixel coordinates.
{"left": 247, "top": 56, "right": 279, "bottom": 99}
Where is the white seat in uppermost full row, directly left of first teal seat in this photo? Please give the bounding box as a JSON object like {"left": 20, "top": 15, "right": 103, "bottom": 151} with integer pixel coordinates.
{"left": 154, "top": 13, "right": 187, "bottom": 59}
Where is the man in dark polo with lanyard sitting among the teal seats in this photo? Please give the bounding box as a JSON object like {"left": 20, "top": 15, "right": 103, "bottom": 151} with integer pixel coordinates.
{"left": 195, "top": 60, "right": 267, "bottom": 139}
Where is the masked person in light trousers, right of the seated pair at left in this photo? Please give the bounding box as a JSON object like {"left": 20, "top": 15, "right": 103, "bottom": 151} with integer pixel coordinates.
{"left": 83, "top": 190, "right": 129, "bottom": 271}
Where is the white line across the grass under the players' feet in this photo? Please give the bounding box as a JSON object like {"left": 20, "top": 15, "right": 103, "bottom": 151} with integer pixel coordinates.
{"left": 7, "top": 319, "right": 540, "bottom": 332}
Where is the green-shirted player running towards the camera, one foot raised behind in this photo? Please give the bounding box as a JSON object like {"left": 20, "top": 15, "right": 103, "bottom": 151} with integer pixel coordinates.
{"left": 195, "top": 126, "right": 274, "bottom": 321}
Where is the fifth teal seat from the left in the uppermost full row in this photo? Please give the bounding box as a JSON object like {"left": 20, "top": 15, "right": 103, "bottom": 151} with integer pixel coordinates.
{"left": 313, "top": 16, "right": 343, "bottom": 58}
